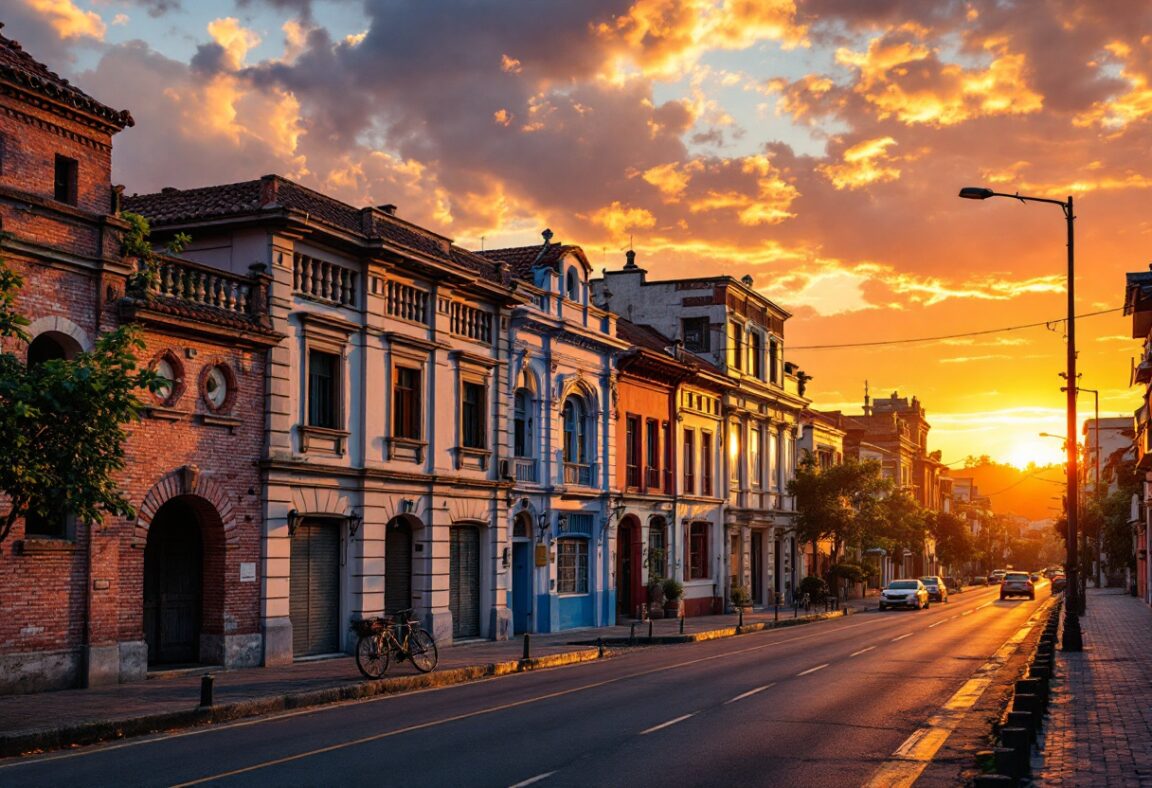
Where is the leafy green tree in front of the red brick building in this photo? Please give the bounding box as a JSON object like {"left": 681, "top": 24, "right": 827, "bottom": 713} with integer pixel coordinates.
{"left": 0, "top": 260, "right": 161, "bottom": 541}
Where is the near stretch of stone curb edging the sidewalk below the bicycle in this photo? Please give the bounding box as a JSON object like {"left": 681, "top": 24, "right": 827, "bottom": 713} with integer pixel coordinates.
{"left": 0, "top": 649, "right": 600, "bottom": 758}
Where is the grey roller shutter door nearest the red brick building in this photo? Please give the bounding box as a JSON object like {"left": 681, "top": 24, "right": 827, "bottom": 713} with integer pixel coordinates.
{"left": 288, "top": 522, "right": 340, "bottom": 657}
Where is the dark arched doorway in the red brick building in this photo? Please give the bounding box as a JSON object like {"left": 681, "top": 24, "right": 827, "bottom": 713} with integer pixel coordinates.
{"left": 144, "top": 498, "right": 204, "bottom": 665}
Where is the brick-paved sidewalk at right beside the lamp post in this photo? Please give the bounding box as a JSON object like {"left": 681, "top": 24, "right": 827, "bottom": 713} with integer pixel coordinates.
{"left": 1033, "top": 589, "right": 1152, "bottom": 788}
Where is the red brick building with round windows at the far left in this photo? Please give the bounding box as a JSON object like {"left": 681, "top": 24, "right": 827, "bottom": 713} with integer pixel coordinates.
{"left": 0, "top": 27, "right": 276, "bottom": 692}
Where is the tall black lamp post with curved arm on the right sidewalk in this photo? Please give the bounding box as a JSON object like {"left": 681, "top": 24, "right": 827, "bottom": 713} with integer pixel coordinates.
{"left": 960, "top": 187, "right": 1084, "bottom": 651}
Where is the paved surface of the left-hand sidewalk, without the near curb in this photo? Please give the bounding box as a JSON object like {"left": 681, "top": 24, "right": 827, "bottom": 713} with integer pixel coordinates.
{"left": 0, "top": 598, "right": 876, "bottom": 740}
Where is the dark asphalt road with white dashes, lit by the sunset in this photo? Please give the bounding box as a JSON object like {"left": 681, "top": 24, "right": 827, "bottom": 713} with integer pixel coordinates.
{"left": 0, "top": 584, "right": 1048, "bottom": 788}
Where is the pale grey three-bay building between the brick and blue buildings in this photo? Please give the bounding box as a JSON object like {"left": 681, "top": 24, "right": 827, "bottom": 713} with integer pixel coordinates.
{"left": 126, "top": 175, "right": 520, "bottom": 665}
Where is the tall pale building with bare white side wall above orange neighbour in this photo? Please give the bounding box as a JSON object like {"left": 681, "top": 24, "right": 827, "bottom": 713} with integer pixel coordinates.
{"left": 593, "top": 252, "right": 808, "bottom": 612}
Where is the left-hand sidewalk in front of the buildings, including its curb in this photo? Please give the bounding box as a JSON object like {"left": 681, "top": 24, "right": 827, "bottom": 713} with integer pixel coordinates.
{"left": 0, "top": 597, "right": 876, "bottom": 757}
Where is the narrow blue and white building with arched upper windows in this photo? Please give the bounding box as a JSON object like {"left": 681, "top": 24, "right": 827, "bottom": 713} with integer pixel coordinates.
{"left": 480, "top": 230, "right": 628, "bottom": 632}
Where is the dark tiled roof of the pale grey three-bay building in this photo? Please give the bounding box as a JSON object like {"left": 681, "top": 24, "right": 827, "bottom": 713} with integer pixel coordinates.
{"left": 123, "top": 175, "right": 507, "bottom": 283}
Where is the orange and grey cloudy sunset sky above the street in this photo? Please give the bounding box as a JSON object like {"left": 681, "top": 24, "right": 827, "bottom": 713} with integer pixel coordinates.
{"left": 0, "top": 0, "right": 1152, "bottom": 467}
